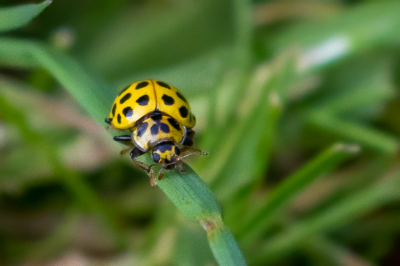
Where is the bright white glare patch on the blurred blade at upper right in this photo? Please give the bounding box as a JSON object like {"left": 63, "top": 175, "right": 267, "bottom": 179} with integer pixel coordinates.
{"left": 298, "top": 37, "right": 350, "bottom": 71}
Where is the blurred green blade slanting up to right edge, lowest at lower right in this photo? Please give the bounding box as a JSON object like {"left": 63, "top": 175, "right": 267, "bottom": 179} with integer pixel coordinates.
{"left": 252, "top": 172, "right": 400, "bottom": 264}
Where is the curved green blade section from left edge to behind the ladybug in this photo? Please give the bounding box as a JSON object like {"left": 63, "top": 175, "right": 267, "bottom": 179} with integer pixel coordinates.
{"left": 0, "top": 38, "right": 115, "bottom": 124}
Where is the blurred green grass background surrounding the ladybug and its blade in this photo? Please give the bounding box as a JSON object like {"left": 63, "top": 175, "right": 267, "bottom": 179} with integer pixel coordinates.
{"left": 0, "top": 0, "right": 400, "bottom": 266}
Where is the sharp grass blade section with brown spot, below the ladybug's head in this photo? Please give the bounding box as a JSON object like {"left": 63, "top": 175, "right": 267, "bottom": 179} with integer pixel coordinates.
{"left": 147, "top": 157, "right": 246, "bottom": 265}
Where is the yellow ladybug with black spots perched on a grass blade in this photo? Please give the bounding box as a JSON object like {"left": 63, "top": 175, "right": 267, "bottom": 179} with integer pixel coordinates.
{"left": 105, "top": 80, "right": 208, "bottom": 186}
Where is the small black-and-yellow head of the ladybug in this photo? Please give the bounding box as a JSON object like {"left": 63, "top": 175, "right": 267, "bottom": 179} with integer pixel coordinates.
{"left": 153, "top": 142, "right": 180, "bottom": 169}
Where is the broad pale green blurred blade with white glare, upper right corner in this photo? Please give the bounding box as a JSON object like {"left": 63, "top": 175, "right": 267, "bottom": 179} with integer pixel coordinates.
{"left": 274, "top": 1, "right": 400, "bottom": 72}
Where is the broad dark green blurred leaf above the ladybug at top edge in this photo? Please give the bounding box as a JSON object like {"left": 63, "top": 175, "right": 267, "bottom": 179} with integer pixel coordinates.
{"left": 79, "top": 0, "right": 232, "bottom": 82}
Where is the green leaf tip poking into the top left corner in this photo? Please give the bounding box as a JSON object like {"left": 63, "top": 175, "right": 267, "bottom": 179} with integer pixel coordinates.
{"left": 0, "top": 0, "right": 52, "bottom": 32}
